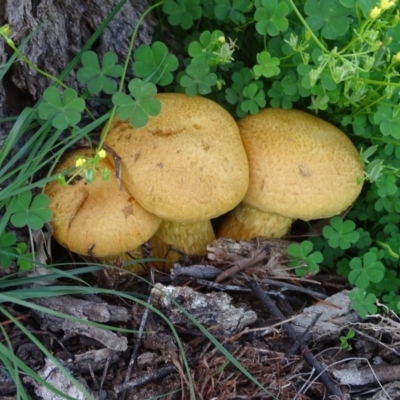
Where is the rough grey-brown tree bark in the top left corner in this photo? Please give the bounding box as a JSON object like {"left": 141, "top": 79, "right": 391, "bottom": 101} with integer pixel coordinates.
{"left": 0, "top": 0, "right": 155, "bottom": 131}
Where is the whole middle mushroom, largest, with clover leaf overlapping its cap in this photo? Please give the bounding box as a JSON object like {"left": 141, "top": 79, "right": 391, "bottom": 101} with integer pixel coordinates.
{"left": 105, "top": 93, "right": 249, "bottom": 268}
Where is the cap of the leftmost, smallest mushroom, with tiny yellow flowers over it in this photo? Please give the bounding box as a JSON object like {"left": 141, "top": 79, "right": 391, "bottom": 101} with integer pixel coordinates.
{"left": 45, "top": 149, "right": 161, "bottom": 257}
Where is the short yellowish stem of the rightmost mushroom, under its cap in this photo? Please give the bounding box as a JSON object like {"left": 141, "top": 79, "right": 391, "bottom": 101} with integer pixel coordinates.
{"left": 217, "top": 203, "right": 293, "bottom": 240}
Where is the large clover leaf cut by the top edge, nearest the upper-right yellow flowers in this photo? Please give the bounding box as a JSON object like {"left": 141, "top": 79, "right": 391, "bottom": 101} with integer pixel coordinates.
{"left": 304, "top": 0, "right": 352, "bottom": 39}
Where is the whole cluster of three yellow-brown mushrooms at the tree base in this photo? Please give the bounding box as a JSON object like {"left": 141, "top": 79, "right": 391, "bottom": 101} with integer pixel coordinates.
{"left": 45, "top": 93, "right": 363, "bottom": 272}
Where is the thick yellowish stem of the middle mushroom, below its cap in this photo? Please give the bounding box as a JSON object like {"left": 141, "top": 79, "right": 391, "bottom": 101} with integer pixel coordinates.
{"left": 150, "top": 220, "right": 215, "bottom": 270}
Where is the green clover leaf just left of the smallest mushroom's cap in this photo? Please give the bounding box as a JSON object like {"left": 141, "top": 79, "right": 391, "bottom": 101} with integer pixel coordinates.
{"left": 10, "top": 190, "right": 52, "bottom": 229}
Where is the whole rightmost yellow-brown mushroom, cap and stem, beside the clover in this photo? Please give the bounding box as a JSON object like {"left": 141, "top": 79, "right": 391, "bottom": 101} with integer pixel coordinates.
{"left": 218, "top": 108, "right": 363, "bottom": 240}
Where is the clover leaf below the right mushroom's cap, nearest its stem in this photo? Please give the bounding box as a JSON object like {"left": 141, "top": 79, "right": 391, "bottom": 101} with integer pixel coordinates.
{"left": 287, "top": 240, "right": 323, "bottom": 277}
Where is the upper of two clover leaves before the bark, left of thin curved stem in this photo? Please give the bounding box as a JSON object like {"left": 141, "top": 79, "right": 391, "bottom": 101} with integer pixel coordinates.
{"left": 76, "top": 51, "right": 123, "bottom": 94}
